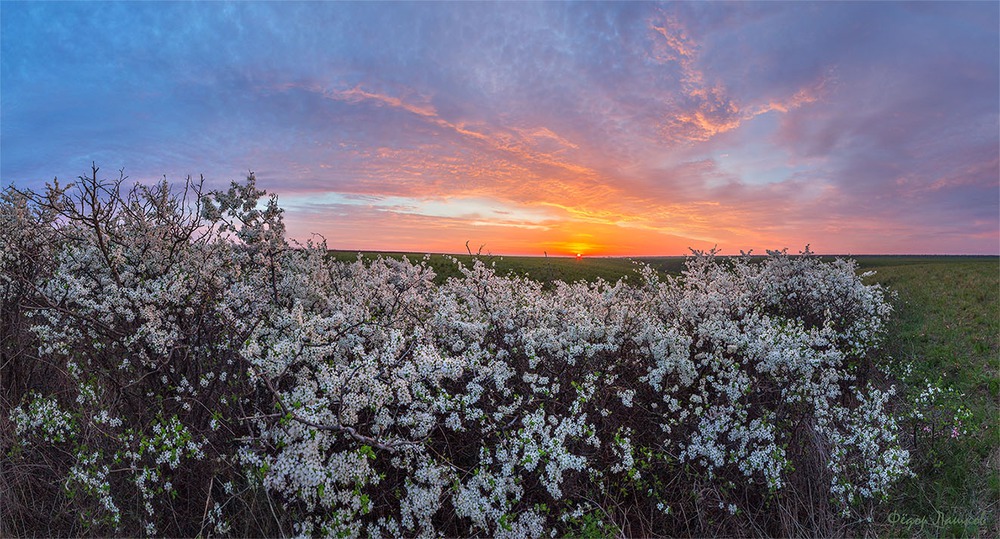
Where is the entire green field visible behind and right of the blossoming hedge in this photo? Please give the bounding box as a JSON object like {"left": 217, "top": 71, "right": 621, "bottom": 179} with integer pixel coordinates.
{"left": 331, "top": 252, "right": 1000, "bottom": 537}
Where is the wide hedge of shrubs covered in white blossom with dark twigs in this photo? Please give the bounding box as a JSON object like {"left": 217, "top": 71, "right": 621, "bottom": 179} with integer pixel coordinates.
{"left": 0, "top": 169, "right": 909, "bottom": 537}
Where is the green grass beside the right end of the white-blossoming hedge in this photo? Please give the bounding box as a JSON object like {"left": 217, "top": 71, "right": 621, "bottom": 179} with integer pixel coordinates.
{"left": 859, "top": 257, "right": 1000, "bottom": 537}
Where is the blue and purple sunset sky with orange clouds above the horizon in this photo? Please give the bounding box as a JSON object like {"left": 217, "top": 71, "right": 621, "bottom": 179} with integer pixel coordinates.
{"left": 0, "top": 1, "right": 1000, "bottom": 256}
